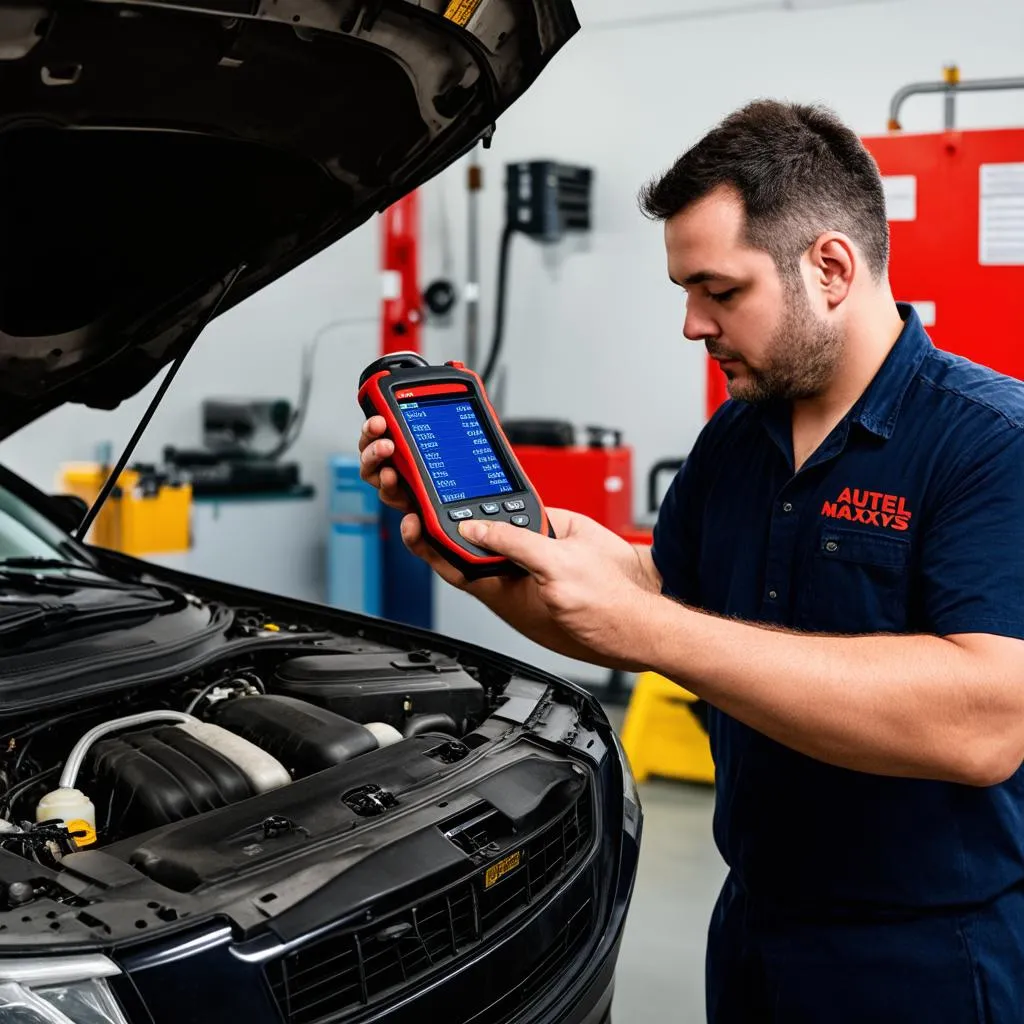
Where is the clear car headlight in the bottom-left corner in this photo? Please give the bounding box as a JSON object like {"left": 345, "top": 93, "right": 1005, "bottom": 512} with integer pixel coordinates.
{"left": 0, "top": 956, "right": 128, "bottom": 1024}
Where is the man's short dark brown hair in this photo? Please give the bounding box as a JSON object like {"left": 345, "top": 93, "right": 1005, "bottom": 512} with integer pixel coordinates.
{"left": 640, "top": 100, "right": 889, "bottom": 280}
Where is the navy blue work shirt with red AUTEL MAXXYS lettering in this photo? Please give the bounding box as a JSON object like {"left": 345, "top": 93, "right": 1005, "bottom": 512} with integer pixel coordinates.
{"left": 653, "top": 305, "right": 1024, "bottom": 910}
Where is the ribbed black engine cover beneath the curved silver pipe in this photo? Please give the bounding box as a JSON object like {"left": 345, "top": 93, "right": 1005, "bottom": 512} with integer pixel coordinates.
{"left": 88, "top": 725, "right": 255, "bottom": 835}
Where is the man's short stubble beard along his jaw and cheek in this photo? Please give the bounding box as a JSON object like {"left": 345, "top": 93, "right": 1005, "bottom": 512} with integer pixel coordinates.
{"left": 726, "top": 283, "right": 843, "bottom": 406}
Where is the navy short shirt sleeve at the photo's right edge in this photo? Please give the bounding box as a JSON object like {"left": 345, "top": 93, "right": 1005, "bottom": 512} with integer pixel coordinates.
{"left": 921, "top": 424, "right": 1024, "bottom": 639}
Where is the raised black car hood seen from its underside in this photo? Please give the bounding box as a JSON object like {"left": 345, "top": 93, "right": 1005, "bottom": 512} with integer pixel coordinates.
{"left": 0, "top": 0, "right": 579, "bottom": 437}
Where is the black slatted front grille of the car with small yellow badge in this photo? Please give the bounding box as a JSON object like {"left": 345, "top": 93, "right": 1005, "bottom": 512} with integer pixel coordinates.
{"left": 267, "top": 788, "right": 594, "bottom": 1024}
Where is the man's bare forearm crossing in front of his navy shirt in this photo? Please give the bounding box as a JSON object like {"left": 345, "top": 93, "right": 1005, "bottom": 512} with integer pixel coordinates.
{"left": 644, "top": 598, "right": 1024, "bottom": 784}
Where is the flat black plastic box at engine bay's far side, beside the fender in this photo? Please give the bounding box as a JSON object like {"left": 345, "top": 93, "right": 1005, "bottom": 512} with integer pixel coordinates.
{"left": 274, "top": 651, "right": 486, "bottom": 734}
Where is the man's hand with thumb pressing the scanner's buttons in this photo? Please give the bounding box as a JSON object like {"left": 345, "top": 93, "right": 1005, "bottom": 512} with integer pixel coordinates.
{"left": 459, "top": 509, "right": 664, "bottom": 671}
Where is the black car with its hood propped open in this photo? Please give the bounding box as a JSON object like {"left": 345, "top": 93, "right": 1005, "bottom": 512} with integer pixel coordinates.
{"left": 0, "top": 0, "right": 641, "bottom": 1024}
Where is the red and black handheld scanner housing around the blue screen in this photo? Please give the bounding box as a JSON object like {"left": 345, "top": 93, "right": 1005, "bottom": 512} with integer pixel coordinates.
{"left": 358, "top": 352, "right": 554, "bottom": 580}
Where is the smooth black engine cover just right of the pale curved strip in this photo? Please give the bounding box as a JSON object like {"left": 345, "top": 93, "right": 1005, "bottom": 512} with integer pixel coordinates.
{"left": 210, "top": 694, "right": 378, "bottom": 778}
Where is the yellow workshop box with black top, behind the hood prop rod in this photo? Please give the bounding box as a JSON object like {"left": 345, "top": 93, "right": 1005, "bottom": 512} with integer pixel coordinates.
{"left": 60, "top": 463, "right": 193, "bottom": 557}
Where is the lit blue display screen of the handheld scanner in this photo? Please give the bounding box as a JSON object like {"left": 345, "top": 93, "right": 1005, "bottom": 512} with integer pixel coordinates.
{"left": 398, "top": 398, "right": 515, "bottom": 505}
